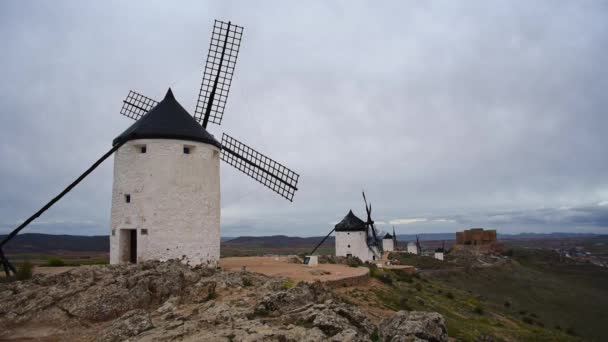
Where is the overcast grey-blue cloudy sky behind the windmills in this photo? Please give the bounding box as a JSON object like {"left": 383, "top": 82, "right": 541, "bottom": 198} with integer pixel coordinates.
{"left": 0, "top": 1, "right": 608, "bottom": 236}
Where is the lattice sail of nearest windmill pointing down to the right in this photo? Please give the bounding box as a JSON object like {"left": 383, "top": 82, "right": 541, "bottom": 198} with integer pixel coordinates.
{"left": 221, "top": 133, "right": 300, "bottom": 201}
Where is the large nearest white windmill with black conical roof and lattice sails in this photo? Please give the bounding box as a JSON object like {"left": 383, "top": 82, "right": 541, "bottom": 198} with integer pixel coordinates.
{"left": 0, "top": 20, "right": 299, "bottom": 275}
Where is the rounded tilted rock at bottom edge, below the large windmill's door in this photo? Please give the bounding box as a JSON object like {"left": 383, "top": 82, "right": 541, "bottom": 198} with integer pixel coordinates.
{"left": 98, "top": 309, "right": 154, "bottom": 342}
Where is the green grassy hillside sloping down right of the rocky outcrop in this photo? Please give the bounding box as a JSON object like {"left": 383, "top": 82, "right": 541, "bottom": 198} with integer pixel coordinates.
{"left": 344, "top": 247, "right": 608, "bottom": 341}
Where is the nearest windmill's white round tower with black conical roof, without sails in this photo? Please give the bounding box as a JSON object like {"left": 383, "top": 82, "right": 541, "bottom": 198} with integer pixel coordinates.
{"left": 110, "top": 90, "right": 221, "bottom": 266}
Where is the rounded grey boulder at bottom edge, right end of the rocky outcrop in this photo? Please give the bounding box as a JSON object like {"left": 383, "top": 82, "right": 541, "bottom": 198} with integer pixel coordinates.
{"left": 378, "top": 311, "right": 448, "bottom": 342}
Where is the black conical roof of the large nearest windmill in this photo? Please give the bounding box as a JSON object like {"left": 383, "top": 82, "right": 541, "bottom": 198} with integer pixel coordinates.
{"left": 112, "top": 88, "right": 221, "bottom": 147}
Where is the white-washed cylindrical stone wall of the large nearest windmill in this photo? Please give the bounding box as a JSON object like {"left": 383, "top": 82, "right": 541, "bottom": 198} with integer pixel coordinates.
{"left": 110, "top": 139, "right": 220, "bottom": 266}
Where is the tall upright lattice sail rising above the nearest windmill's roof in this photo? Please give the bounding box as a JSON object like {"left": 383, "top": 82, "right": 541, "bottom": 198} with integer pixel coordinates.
{"left": 194, "top": 20, "right": 243, "bottom": 128}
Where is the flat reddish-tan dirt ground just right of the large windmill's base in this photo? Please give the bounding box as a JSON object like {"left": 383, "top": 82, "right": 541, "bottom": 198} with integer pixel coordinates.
{"left": 220, "top": 256, "right": 369, "bottom": 282}
